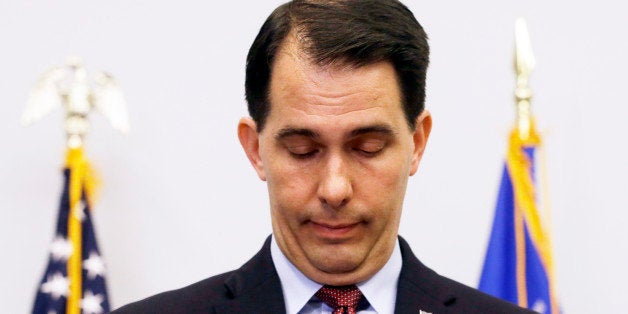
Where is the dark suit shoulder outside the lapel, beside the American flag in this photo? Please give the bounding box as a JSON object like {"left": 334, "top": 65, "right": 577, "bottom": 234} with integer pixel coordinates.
{"left": 112, "top": 271, "right": 234, "bottom": 314}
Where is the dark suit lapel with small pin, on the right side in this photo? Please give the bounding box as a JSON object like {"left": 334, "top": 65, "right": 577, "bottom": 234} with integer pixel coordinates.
{"left": 395, "top": 237, "right": 455, "bottom": 314}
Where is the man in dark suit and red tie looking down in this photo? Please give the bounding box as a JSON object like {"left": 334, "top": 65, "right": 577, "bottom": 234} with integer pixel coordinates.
{"left": 114, "top": 0, "right": 526, "bottom": 313}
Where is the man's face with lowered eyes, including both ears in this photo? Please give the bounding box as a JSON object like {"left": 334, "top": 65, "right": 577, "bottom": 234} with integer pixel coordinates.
{"left": 239, "top": 42, "right": 431, "bottom": 285}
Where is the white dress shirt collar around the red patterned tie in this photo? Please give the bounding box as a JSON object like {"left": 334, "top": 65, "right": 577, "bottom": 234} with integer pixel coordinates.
{"left": 270, "top": 236, "right": 402, "bottom": 314}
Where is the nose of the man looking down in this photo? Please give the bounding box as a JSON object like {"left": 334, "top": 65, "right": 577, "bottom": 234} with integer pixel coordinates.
{"left": 318, "top": 156, "right": 353, "bottom": 210}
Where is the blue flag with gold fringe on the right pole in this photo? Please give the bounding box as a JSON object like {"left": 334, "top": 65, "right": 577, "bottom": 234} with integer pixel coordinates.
{"left": 479, "top": 130, "right": 559, "bottom": 314}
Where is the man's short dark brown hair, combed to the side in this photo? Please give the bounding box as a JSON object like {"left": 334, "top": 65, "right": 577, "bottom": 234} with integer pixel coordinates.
{"left": 245, "top": 0, "right": 429, "bottom": 131}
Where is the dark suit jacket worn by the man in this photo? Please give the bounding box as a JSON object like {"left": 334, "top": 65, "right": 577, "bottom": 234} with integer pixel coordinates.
{"left": 114, "top": 237, "right": 533, "bottom": 314}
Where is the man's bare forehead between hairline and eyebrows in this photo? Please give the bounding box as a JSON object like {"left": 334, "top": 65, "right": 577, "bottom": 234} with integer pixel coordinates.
{"left": 267, "top": 39, "right": 404, "bottom": 131}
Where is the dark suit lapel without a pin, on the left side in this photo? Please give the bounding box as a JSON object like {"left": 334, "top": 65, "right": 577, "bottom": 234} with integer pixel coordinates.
{"left": 216, "top": 237, "right": 286, "bottom": 314}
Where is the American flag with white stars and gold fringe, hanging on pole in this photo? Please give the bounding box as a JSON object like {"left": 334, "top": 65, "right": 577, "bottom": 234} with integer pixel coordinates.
{"left": 33, "top": 150, "right": 109, "bottom": 314}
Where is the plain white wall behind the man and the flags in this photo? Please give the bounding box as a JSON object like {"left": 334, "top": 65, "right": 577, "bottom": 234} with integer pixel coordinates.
{"left": 0, "top": 0, "right": 628, "bottom": 313}
